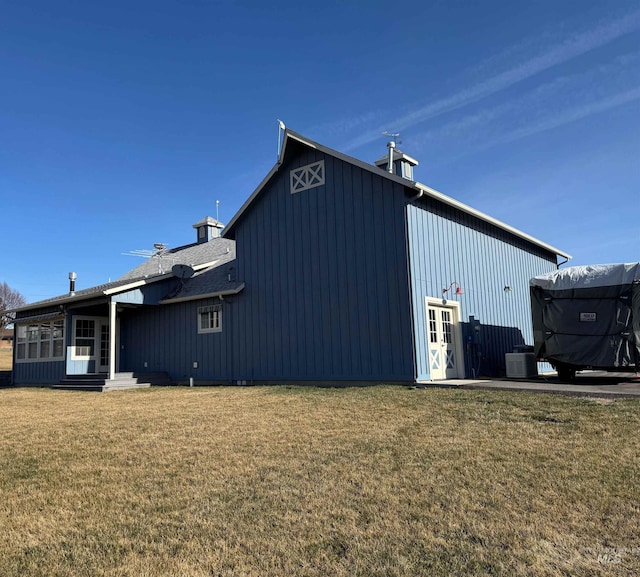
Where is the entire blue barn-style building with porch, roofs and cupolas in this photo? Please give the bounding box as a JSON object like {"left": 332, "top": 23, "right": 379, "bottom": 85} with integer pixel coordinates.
{"left": 13, "top": 129, "right": 570, "bottom": 388}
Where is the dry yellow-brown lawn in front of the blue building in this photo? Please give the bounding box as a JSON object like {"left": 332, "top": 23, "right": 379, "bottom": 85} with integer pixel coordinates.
{"left": 0, "top": 387, "right": 640, "bottom": 577}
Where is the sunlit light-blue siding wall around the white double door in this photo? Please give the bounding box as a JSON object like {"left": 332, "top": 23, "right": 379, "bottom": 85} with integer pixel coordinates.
{"left": 407, "top": 199, "right": 556, "bottom": 380}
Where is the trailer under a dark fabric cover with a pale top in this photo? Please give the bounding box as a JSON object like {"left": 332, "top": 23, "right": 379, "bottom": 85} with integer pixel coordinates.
{"left": 530, "top": 263, "right": 640, "bottom": 380}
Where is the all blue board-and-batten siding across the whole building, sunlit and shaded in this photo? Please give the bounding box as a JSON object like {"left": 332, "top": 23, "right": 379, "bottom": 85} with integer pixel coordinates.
{"left": 14, "top": 131, "right": 556, "bottom": 384}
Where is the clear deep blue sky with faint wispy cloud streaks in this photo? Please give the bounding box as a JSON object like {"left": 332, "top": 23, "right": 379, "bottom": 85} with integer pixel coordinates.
{"left": 0, "top": 0, "right": 640, "bottom": 302}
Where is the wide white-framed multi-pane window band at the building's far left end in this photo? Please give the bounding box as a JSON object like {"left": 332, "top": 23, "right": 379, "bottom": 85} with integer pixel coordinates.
{"left": 16, "top": 319, "right": 64, "bottom": 362}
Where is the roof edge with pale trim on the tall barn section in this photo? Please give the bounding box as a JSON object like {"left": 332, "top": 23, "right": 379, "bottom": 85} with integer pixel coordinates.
{"left": 222, "top": 128, "right": 572, "bottom": 259}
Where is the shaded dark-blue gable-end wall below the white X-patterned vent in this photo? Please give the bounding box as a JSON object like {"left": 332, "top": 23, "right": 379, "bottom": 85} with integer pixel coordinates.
{"left": 231, "top": 145, "right": 414, "bottom": 381}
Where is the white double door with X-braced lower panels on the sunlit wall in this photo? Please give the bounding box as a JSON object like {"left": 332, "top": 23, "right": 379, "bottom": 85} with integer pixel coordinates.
{"left": 427, "top": 300, "right": 464, "bottom": 381}
